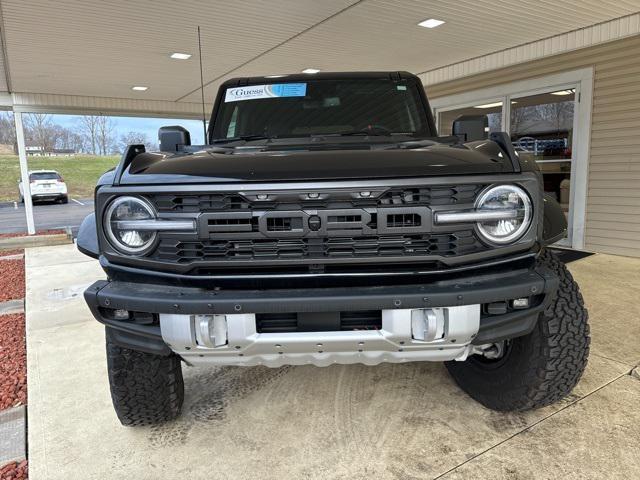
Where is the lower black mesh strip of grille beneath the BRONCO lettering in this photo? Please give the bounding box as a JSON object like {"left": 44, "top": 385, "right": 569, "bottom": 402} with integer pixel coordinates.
{"left": 156, "top": 230, "right": 482, "bottom": 263}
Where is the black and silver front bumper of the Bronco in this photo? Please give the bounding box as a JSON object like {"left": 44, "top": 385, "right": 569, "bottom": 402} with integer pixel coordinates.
{"left": 85, "top": 267, "right": 558, "bottom": 366}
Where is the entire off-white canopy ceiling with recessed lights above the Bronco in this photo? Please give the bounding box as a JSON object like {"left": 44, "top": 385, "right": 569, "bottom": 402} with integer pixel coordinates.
{"left": 0, "top": 0, "right": 640, "bottom": 108}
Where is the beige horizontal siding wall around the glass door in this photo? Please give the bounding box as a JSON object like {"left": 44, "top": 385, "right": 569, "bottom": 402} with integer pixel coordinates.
{"left": 427, "top": 36, "right": 640, "bottom": 257}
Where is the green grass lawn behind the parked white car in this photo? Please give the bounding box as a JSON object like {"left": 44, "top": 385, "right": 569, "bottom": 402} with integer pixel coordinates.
{"left": 0, "top": 155, "right": 120, "bottom": 202}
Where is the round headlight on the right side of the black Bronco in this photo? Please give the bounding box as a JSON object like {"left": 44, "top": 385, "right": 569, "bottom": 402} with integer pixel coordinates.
{"left": 476, "top": 185, "right": 533, "bottom": 244}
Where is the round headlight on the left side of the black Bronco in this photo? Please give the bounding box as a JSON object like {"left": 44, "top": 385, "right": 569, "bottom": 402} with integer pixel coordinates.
{"left": 104, "top": 197, "right": 156, "bottom": 255}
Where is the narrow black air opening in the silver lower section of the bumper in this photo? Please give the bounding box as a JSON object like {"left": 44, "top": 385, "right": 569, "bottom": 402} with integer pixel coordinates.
{"left": 256, "top": 310, "right": 382, "bottom": 333}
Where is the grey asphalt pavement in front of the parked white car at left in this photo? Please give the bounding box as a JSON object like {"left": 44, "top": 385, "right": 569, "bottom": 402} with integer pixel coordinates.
{"left": 0, "top": 199, "right": 93, "bottom": 233}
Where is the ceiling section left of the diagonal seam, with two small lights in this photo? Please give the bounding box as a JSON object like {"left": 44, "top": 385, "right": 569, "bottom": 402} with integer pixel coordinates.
{"left": 2, "top": 0, "right": 353, "bottom": 100}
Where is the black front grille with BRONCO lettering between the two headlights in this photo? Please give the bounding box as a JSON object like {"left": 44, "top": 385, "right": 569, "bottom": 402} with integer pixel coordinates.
{"left": 150, "top": 184, "right": 485, "bottom": 270}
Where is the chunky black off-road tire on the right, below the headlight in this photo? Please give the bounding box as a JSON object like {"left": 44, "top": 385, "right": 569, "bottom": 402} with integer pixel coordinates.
{"left": 446, "top": 250, "right": 590, "bottom": 411}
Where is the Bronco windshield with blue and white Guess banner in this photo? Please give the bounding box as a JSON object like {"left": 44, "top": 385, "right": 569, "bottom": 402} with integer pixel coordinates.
{"left": 213, "top": 79, "right": 430, "bottom": 141}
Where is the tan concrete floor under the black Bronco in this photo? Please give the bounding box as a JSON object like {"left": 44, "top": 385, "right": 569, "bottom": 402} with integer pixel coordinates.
{"left": 26, "top": 245, "right": 640, "bottom": 480}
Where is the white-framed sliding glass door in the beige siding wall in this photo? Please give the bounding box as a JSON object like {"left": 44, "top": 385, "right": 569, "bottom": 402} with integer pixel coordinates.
{"left": 427, "top": 68, "right": 593, "bottom": 249}
